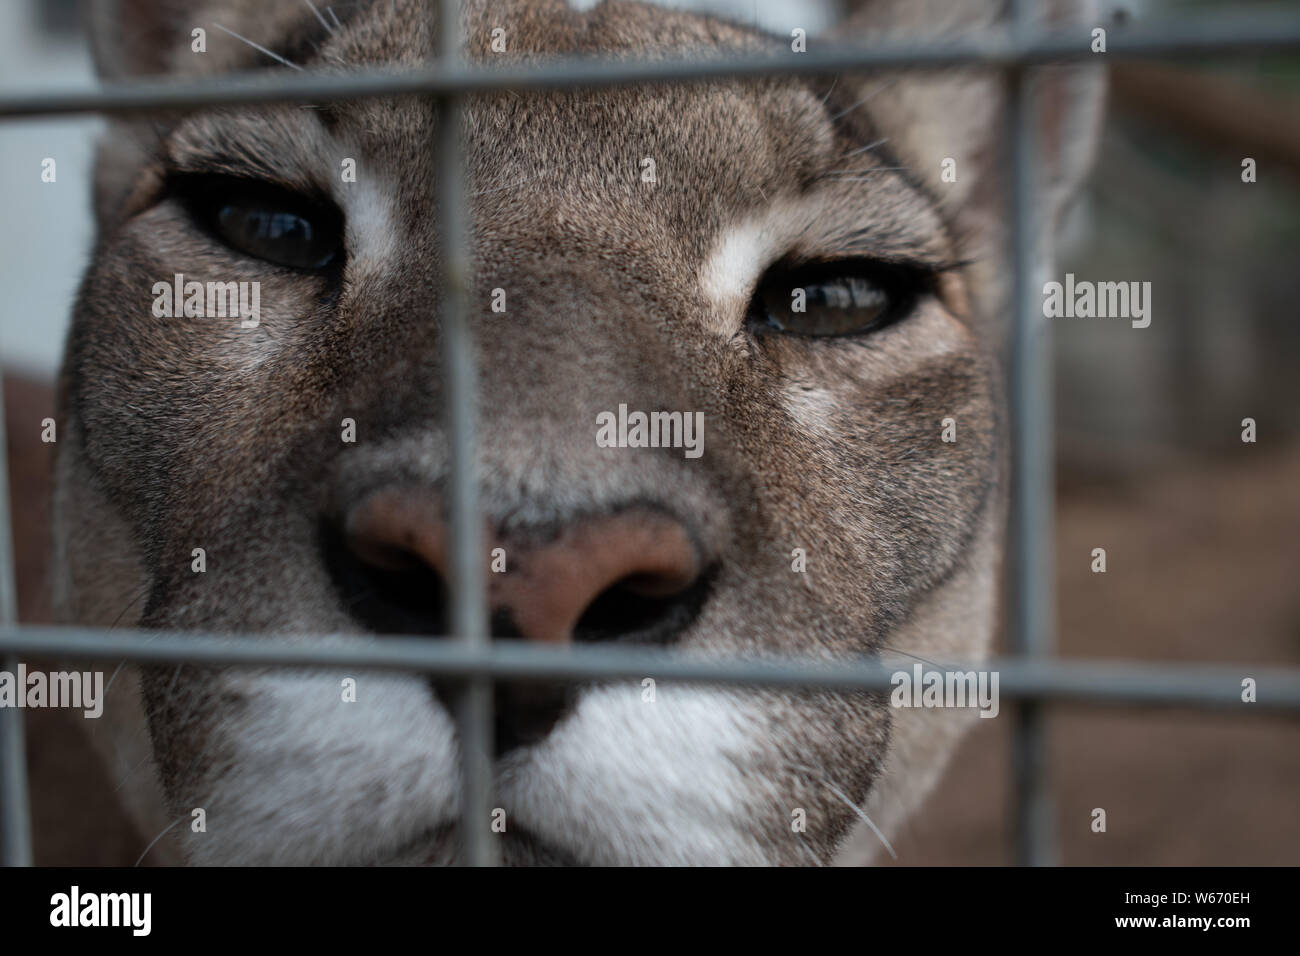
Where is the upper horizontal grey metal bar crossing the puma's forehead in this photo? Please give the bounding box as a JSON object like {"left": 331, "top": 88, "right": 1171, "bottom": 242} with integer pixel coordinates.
{"left": 0, "top": 17, "right": 1300, "bottom": 118}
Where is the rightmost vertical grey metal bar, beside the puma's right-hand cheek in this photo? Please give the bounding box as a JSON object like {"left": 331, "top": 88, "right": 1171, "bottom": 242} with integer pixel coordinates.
{"left": 1006, "top": 0, "right": 1057, "bottom": 866}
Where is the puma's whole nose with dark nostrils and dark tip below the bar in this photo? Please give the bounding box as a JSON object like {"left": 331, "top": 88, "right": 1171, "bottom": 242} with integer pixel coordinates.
{"left": 330, "top": 489, "right": 707, "bottom": 753}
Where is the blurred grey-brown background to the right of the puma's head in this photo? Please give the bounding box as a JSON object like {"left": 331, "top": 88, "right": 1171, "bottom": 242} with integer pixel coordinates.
{"left": 894, "top": 0, "right": 1300, "bottom": 865}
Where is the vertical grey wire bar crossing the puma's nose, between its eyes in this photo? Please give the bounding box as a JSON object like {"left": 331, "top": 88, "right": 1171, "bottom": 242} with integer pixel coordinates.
{"left": 433, "top": 0, "right": 497, "bottom": 866}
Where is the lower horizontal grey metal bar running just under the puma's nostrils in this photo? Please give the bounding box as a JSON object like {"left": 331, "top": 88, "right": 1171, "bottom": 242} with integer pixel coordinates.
{"left": 0, "top": 627, "right": 1300, "bottom": 713}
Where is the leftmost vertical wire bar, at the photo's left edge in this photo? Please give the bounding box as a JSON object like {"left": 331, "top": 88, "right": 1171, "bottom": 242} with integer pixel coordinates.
{"left": 0, "top": 376, "right": 31, "bottom": 866}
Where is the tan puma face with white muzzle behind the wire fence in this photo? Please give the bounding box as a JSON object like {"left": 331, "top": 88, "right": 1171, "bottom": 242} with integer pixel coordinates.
{"left": 57, "top": 0, "right": 1096, "bottom": 865}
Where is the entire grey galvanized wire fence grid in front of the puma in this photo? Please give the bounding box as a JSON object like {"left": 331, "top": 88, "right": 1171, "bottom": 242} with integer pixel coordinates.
{"left": 0, "top": 0, "right": 1300, "bottom": 865}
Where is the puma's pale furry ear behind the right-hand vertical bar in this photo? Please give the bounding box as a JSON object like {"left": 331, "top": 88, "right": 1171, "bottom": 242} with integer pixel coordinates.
{"left": 837, "top": 0, "right": 1105, "bottom": 257}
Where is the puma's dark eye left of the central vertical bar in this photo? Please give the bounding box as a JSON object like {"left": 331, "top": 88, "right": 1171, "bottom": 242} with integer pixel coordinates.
{"left": 181, "top": 177, "right": 343, "bottom": 272}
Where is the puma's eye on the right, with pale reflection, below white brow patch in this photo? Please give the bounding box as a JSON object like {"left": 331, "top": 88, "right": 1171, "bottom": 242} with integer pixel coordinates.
{"left": 746, "top": 260, "right": 933, "bottom": 338}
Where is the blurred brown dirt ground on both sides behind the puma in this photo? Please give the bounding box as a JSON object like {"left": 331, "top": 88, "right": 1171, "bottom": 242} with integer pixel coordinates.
{"left": 5, "top": 377, "right": 1300, "bottom": 865}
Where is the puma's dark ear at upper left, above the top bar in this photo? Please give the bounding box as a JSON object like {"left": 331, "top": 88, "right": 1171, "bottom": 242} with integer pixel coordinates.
{"left": 87, "top": 0, "right": 207, "bottom": 79}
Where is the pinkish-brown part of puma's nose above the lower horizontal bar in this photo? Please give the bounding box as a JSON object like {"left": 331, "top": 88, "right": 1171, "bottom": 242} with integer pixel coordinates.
{"left": 345, "top": 489, "right": 701, "bottom": 644}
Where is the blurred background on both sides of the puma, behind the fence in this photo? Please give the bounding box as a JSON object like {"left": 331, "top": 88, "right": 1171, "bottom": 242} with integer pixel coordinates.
{"left": 0, "top": 0, "right": 1300, "bottom": 865}
